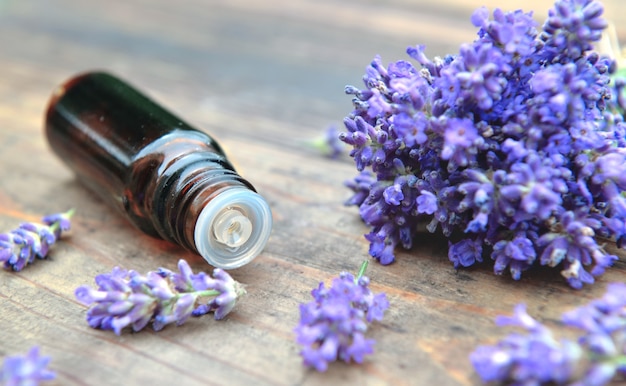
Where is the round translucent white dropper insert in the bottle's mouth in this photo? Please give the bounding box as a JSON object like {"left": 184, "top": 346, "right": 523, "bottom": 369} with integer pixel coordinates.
{"left": 194, "top": 187, "right": 272, "bottom": 269}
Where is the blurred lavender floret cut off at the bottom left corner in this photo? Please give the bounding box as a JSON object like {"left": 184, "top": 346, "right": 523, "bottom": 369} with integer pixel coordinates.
{"left": 0, "top": 346, "right": 56, "bottom": 386}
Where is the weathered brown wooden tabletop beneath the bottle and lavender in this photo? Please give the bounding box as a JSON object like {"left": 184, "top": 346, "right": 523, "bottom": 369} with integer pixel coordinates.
{"left": 0, "top": 0, "right": 626, "bottom": 386}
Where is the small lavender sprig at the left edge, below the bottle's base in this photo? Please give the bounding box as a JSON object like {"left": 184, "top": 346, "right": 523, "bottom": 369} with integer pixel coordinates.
{"left": 0, "top": 209, "right": 74, "bottom": 271}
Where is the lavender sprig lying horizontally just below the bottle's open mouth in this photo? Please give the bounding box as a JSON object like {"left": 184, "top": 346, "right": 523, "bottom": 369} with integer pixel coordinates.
{"left": 75, "top": 260, "right": 246, "bottom": 335}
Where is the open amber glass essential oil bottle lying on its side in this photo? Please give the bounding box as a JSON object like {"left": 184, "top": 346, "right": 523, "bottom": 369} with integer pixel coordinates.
{"left": 45, "top": 72, "right": 272, "bottom": 269}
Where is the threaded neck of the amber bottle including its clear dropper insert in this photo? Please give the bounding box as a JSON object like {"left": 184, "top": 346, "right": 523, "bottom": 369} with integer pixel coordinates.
{"left": 148, "top": 153, "right": 272, "bottom": 269}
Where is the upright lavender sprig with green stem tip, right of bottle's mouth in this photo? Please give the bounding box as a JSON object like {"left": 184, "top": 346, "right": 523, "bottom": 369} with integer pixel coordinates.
{"left": 294, "top": 262, "right": 389, "bottom": 371}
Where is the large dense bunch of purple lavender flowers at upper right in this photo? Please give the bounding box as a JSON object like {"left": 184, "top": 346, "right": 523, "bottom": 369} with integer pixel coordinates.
{"left": 340, "top": 0, "right": 626, "bottom": 288}
